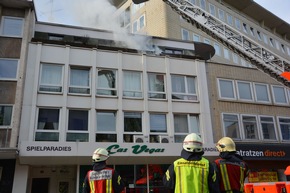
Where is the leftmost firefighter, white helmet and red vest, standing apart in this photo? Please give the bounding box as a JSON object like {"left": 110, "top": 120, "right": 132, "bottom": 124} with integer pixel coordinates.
{"left": 83, "top": 148, "right": 125, "bottom": 193}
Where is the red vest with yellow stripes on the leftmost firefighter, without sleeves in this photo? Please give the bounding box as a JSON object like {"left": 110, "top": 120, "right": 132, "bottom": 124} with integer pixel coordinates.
{"left": 87, "top": 168, "right": 114, "bottom": 193}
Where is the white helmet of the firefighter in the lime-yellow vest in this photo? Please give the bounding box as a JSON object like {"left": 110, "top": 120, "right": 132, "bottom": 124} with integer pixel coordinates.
{"left": 183, "top": 133, "right": 202, "bottom": 152}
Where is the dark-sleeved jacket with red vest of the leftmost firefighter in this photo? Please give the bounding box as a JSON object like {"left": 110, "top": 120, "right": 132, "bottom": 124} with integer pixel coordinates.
{"left": 83, "top": 162, "right": 124, "bottom": 193}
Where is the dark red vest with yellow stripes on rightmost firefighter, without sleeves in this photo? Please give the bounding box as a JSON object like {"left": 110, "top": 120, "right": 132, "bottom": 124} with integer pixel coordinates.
{"left": 215, "top": 159, "right": 247, "bottom": 193}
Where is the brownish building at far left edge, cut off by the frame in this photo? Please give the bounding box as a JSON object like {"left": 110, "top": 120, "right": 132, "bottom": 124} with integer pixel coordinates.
{"left": 0, "top": 0, "right": 34, "bottom": 192}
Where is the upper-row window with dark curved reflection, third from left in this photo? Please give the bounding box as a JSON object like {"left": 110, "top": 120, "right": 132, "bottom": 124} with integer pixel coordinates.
{"left": 97, "top": 69, "right": 117, "bottom": 96}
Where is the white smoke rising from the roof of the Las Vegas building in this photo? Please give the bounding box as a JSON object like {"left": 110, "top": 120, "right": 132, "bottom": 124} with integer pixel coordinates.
{"left": 66, "top": 0, "right": 151, "bottom": 50}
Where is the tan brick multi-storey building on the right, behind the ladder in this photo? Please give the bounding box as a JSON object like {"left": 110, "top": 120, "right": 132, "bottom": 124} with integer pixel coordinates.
{"left": 119, "top": 0, "right": 290, "bottom": 181}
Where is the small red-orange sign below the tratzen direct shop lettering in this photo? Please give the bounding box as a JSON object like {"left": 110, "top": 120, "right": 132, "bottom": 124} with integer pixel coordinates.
{"left": 248, "top": 172, "right": 278, "bottom": 183}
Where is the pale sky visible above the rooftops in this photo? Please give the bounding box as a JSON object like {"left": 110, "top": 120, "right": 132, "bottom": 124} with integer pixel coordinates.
{"left": 34, "top": 0, "right": 290, "bottom": 25}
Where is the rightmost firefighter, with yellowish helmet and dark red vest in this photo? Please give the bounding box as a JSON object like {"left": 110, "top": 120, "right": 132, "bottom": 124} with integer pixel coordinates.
{"left": 215, "top": 137, "right": 249, "bottom": 193}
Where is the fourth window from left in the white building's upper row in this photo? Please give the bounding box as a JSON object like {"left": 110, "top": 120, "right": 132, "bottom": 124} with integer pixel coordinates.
{"left": 123, "top": 71, "right": 143, "bottom": 98}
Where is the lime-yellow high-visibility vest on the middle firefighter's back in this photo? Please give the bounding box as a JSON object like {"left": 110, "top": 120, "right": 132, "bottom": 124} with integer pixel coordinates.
{"left": 174, "top": 158, "right": 209, "bottom": 193}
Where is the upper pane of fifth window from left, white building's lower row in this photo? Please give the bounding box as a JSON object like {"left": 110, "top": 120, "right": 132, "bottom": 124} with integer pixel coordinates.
{"left": 150, "top": 113, "right": 167, "bottom": 133}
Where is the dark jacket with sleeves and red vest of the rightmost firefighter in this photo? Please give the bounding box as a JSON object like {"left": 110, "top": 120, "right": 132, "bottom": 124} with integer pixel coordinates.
{"left": 215, "top": 152, "right": 249, "bottom": 193}
